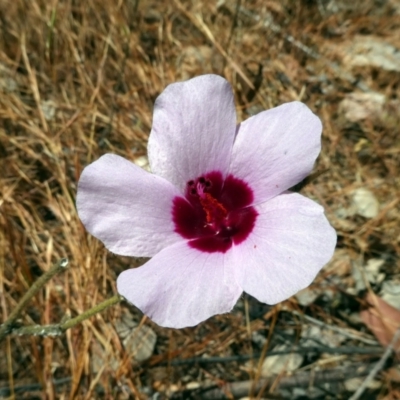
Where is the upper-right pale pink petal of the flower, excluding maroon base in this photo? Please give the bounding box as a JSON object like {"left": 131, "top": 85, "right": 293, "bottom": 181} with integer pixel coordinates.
{"left": 230, "top": 102, "right": 322, "bottom": 204}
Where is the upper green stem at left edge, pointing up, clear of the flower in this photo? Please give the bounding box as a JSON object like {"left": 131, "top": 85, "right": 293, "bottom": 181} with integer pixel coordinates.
{"left": 0, "top": 258, "right": 68, "bottom": 343}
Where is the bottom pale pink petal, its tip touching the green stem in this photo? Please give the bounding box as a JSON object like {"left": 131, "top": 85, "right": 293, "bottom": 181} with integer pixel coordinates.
{"left": 117, "top": 243, "right": 242, "bottom": 328}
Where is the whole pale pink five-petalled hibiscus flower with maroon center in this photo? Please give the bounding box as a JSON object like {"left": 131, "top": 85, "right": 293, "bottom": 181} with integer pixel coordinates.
{"left": 77, "top": 75, "right": 336, "bottom": 328}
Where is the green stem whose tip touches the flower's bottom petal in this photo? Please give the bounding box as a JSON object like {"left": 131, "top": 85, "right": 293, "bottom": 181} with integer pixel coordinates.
{"left": 11, "top": 295, "right": 123, "bottom": 336}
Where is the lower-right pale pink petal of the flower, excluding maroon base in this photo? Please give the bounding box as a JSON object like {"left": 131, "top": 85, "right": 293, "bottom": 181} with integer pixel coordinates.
{"left": 231, "top": 192, "right": 336, "bottom": 304}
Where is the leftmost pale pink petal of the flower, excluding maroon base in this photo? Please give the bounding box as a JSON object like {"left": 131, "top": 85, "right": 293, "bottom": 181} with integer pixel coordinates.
{"left": 76, "top": 154, "right": 182, "bottom": 257}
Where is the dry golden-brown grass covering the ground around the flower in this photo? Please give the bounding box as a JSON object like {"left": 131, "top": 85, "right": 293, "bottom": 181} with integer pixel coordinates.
{"left": 0, "top": 0, "right": 400, "bottom": 399}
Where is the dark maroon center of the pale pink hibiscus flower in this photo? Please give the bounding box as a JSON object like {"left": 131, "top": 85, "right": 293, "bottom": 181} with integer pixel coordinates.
{"left": 172, "top": 171, "right": 258, "bottom": 253}
